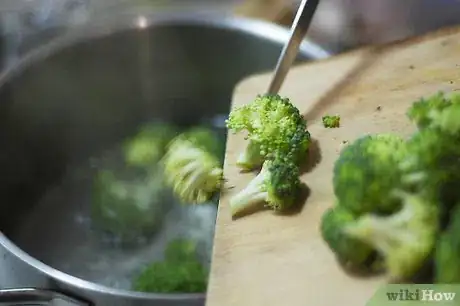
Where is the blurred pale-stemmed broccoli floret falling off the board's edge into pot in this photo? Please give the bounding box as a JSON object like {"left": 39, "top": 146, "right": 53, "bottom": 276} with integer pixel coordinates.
{"left": 163, "top": 127, "right": 223, "bottom": 204}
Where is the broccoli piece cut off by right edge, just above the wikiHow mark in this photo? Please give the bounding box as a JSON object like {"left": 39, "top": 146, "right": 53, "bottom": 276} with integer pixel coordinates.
{"left": 435, "top": 204, "right": 460, "bottom": 284}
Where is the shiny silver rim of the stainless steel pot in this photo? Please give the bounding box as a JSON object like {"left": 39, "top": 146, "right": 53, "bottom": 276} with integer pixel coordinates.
{"left": 0, "top": 12, "right": 331, "bottom": 301}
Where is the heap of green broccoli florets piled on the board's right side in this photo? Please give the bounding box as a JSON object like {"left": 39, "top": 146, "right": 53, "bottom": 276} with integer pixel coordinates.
{"left": 321, "top": 92, "right": 460, "bottom": 284}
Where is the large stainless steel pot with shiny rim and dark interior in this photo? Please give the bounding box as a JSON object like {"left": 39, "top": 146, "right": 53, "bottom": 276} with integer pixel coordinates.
{"left": 0, "top": 13, "right": 328, "bottom": 306}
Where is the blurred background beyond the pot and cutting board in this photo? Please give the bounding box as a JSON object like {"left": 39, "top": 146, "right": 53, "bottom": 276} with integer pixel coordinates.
{"left": 0, "top": 0, "right": 460, "bottom": 65}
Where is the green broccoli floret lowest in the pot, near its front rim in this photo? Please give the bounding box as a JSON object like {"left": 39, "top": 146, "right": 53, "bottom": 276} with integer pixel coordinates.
{"left": 133, "top": 239, "right": 209, "bottom": 293}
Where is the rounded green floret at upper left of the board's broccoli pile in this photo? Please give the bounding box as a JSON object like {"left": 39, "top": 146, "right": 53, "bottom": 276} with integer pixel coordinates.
{"left": 333, "top": 134, "right": 406, "bottom": 214}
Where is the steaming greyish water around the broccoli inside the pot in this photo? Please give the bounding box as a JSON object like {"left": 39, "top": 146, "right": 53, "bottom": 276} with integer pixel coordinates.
{"left": 14, "top": 123, "right": 225, "bottom": 290}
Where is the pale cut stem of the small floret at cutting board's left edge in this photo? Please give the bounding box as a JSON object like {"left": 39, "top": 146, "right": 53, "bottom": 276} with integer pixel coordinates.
{"left": 230, "top": 171, "right": 268, "bottom": 216}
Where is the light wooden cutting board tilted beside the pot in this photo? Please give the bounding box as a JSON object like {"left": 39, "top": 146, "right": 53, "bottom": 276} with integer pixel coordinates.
{"left": 207, "top": 28, "right": 460, "bottom": 306}
